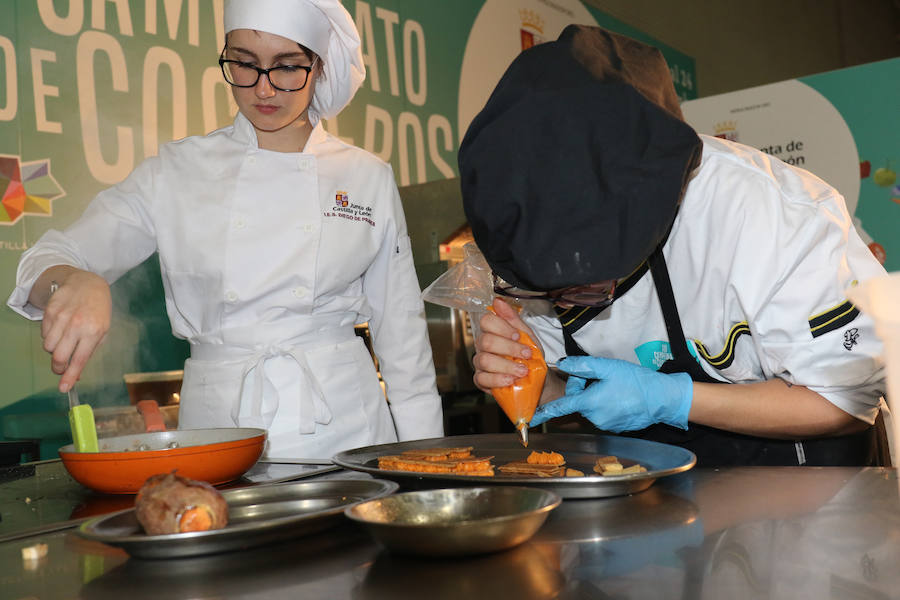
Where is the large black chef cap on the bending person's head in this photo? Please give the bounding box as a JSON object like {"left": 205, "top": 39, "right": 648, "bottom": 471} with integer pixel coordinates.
{"left": 459, "top": 26, "right": 701, "bottom": 290}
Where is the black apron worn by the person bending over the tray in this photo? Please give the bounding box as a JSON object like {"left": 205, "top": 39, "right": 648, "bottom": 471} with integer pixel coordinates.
{"left": 563, "top": 249, "right": 878, "bottom": 467}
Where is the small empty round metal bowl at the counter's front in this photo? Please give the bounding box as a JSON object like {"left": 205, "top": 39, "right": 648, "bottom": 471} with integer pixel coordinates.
{"left": 344, "top": 486, "right": 562, "bottom": 556}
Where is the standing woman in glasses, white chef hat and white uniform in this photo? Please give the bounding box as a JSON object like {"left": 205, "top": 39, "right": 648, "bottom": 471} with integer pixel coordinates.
{"left": 9, "top": 0, "right": 443, "bottom": 458}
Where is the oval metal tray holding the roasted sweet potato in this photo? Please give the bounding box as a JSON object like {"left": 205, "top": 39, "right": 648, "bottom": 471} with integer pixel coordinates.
{"left": 78, "top": 479, "right": 399, "bottom": 558}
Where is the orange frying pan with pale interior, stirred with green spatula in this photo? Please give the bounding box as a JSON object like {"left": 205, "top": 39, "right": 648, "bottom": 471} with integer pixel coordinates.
{"left": 59, "top": 427, "right": 266, "bottom": 494}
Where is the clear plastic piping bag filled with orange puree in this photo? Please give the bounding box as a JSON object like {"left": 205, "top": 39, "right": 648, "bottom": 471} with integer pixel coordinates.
{"left": 422, "top": 242, "right": 547, "bottom": 447}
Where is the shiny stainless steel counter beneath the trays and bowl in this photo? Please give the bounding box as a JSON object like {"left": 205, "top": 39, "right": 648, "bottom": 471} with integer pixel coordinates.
{"left": 0, "top": 462, "right": 900, "bottom": 600}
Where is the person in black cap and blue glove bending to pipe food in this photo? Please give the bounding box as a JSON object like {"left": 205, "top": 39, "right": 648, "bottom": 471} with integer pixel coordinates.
{"left": 459, "top": 26, "right": 884, "bottom": 466}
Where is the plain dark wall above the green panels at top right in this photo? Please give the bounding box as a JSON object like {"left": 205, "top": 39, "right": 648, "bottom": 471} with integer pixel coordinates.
{"left": 584, "top": 0, "right": 900, "bottom": 97}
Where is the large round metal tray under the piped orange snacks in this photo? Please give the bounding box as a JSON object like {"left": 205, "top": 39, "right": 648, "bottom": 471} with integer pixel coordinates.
{"left": 332, "top": 433, "right": 697, "bottom": 498}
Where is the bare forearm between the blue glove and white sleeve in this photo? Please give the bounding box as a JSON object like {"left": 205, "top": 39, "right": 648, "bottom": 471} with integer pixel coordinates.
{"left": 689, "top": 379, "right": 868, "bottom": 439}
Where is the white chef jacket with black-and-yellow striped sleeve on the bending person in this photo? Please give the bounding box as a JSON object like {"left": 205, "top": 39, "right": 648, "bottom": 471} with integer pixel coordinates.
{"left": 525, "top": 136, "right": 885, "bottom": 423}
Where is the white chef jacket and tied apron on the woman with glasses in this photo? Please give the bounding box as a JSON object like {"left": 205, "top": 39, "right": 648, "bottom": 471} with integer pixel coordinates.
{"left": 8, "top": 114, "right": 443, "bottom": 458}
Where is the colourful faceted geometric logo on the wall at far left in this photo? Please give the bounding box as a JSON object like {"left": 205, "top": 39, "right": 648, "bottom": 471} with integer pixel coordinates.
{"left": 0, "top": 155, "right": 65, "bottom": 225}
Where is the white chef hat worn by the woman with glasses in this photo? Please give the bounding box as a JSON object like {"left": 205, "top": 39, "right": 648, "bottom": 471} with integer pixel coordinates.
{"left": 225, "top": 0, "right": 366, "bottom": 125}
